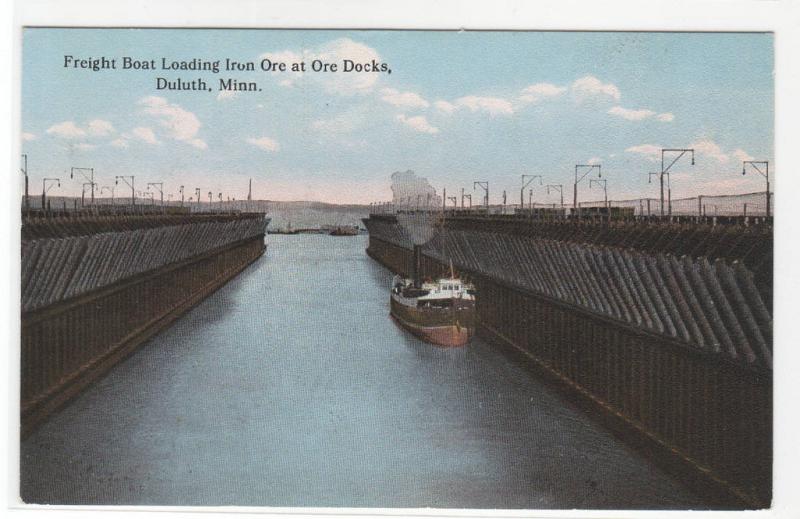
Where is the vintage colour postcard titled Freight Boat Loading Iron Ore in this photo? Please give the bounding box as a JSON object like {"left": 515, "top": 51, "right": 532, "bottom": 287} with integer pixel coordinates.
{"left": 6, "top": 2, "right": 793, "bottom": 514}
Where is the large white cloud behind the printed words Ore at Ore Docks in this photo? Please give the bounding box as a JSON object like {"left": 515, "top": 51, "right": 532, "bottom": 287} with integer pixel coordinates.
{"left": 259, "top": 38, "right": 381, "bottom": 96}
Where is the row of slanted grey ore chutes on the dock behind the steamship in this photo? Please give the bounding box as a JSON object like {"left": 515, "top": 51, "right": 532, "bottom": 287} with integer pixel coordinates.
{"left": 367, "top": 218, "right": 772, "bottom": 370}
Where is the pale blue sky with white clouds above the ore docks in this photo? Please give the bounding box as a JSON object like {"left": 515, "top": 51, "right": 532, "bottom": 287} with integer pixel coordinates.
{"left": 20, "top": 28, "right": 776, "bottom": 204}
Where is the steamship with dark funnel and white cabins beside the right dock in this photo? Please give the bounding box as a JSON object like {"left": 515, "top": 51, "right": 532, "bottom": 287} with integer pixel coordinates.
{"left": 390, "top": 246, "right": 475, "bottom": 347}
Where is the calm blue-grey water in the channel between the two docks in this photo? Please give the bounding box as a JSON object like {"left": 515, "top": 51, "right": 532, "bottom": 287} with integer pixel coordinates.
{"left": 20, "top": 235, "right": 703, "bottom": 508}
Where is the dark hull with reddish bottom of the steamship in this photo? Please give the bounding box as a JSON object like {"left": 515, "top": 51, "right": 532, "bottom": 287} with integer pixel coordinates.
{"left": 391, "top": 298, "right": 475, "bottom": 348}
